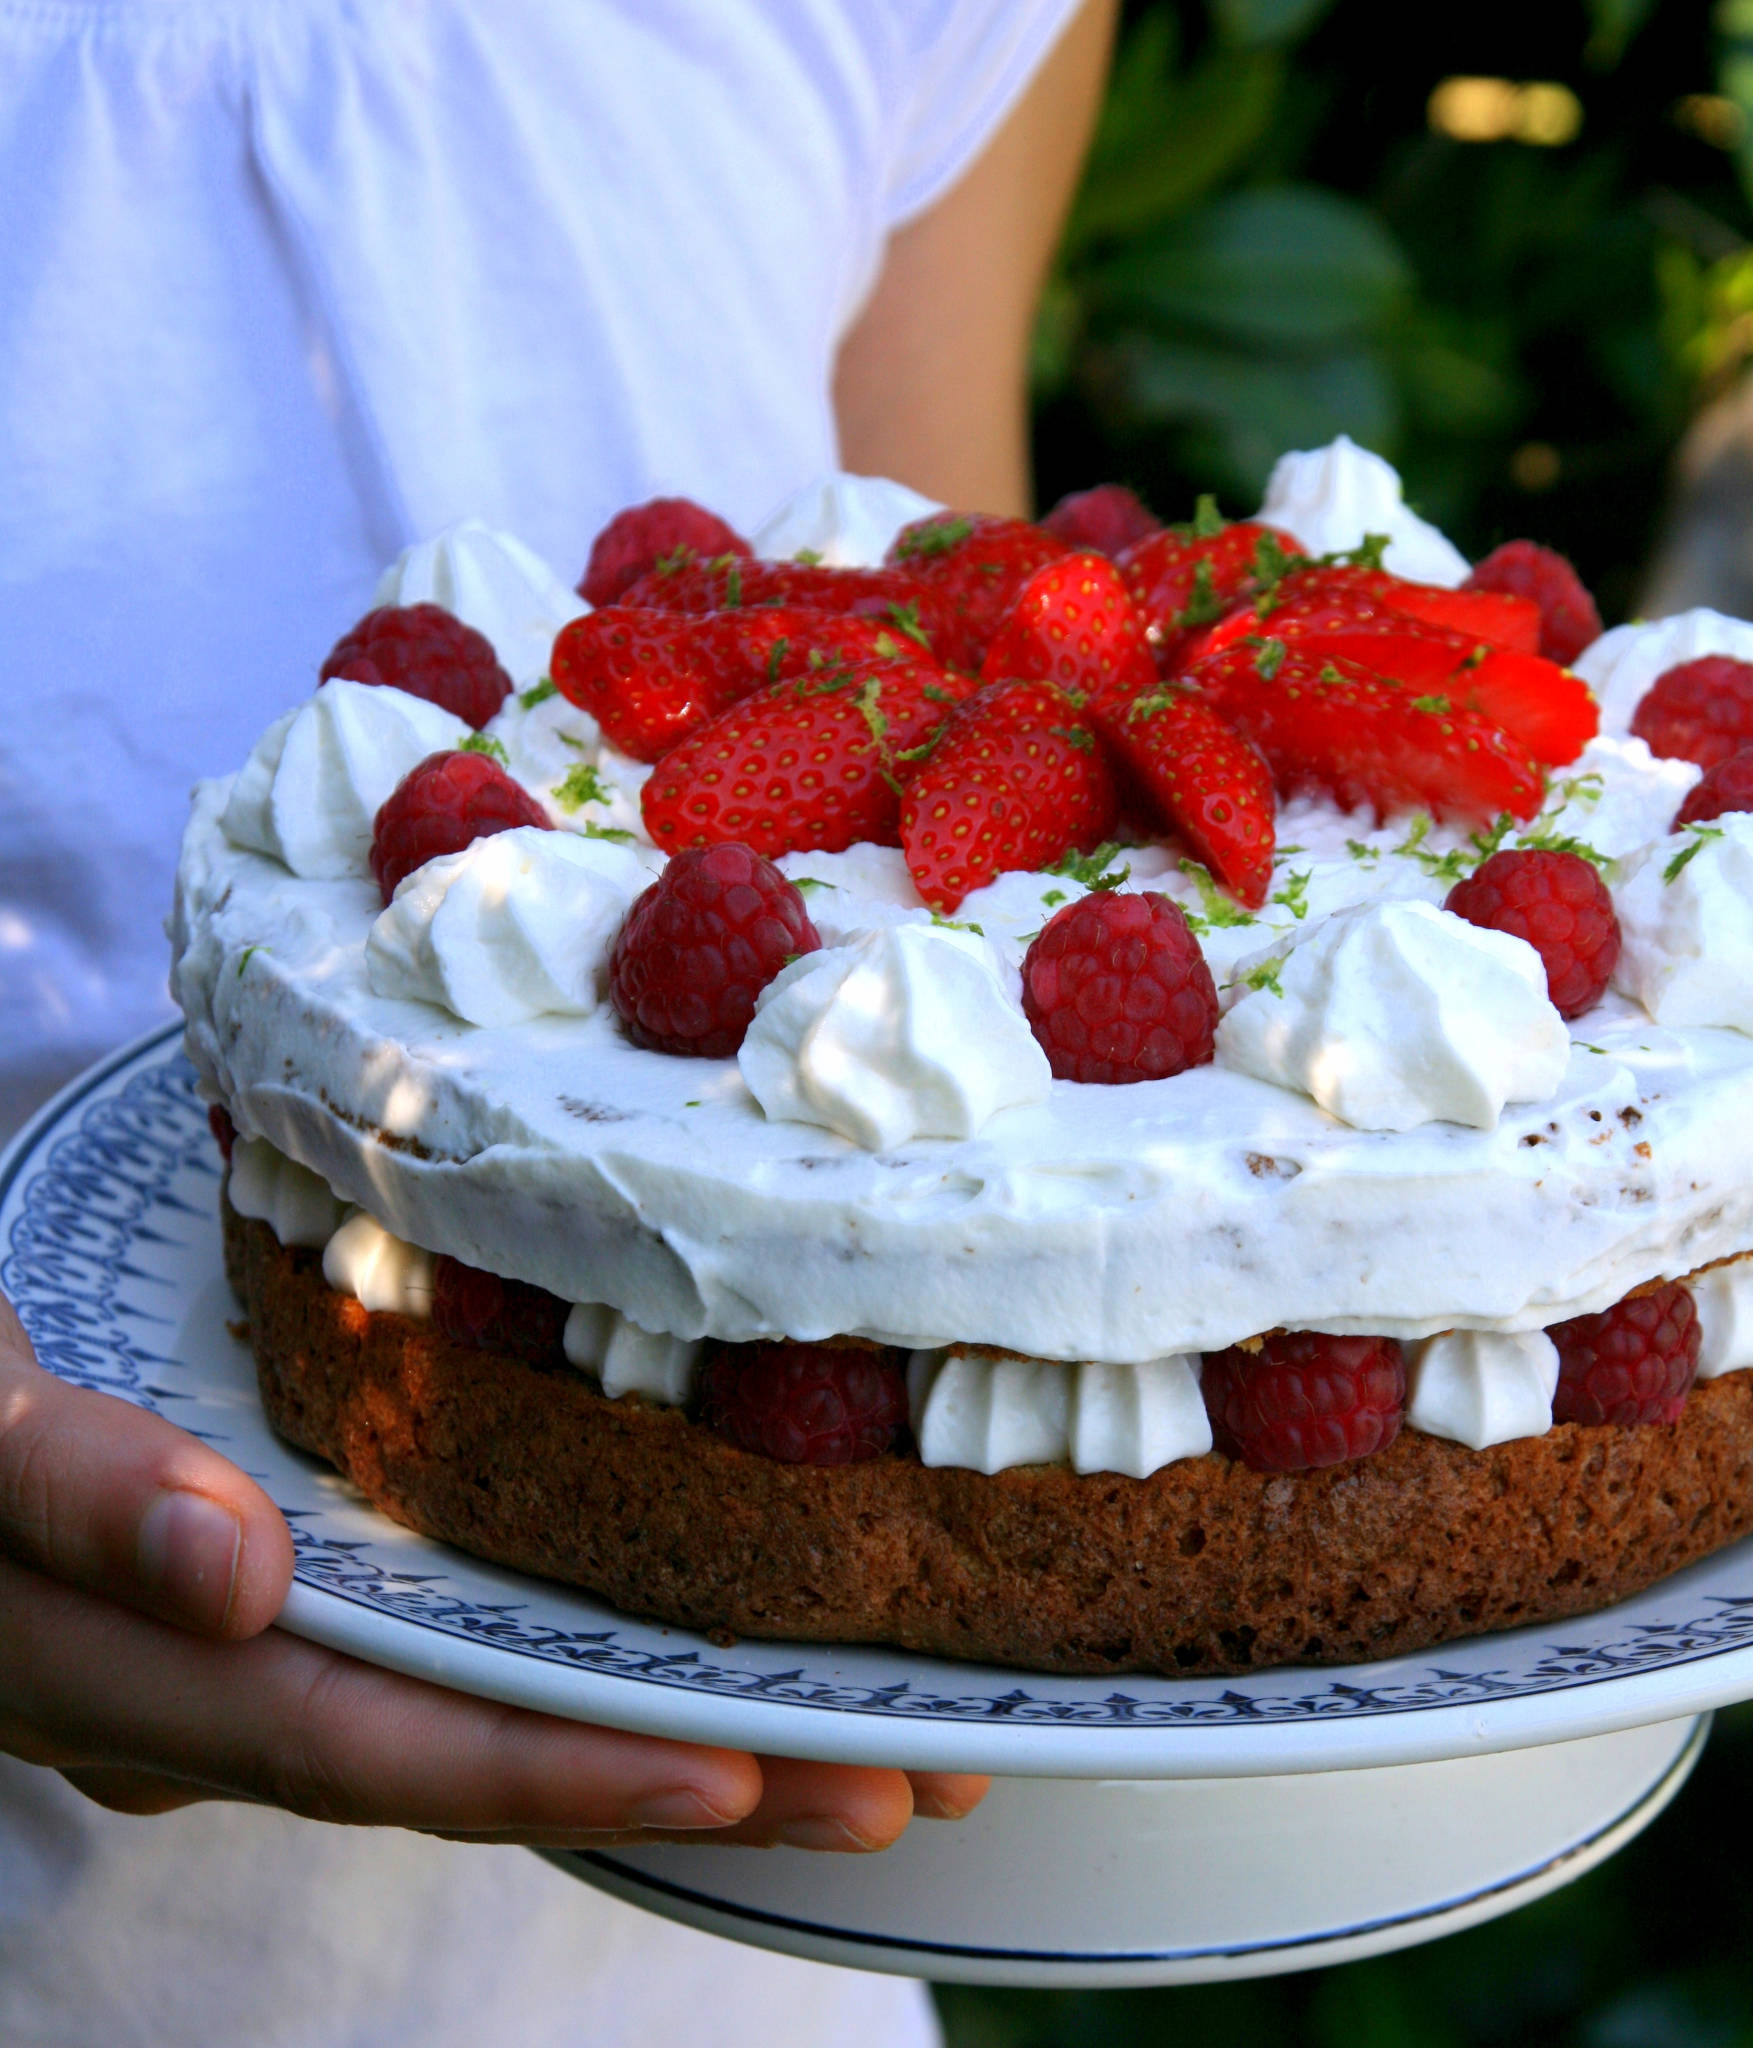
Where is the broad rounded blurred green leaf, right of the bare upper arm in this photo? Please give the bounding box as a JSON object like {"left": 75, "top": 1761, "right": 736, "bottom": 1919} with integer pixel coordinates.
{"left": 1092, "top": 184, "right": 1411, "bottom": 350}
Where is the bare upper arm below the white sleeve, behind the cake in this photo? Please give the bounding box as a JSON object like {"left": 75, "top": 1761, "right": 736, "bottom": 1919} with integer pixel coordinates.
{"left": 833, "top": 0, "right": 1116, "bottom": 516}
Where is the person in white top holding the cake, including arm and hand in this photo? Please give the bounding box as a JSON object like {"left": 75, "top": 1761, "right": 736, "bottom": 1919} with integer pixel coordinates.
{"left": 0, "top": 0, "right": 1114, "bottom": 2048}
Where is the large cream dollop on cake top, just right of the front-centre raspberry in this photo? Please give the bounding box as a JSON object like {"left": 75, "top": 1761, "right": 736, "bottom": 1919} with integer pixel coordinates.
{"left": 1216, "top": 903, "right": 1571, "bottom": 1130}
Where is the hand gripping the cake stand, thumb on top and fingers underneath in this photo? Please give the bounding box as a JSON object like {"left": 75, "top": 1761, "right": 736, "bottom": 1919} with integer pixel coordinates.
{"left": 0, "top": 1298, "right": 987, "bottom": 1849}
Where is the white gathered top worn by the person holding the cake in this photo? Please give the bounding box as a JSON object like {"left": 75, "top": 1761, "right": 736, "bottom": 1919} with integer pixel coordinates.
{"left": 0, "top": 0, "right": 1075, "bottom": 2048}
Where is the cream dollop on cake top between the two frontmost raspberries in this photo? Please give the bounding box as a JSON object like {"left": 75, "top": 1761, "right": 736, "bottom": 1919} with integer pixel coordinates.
{"left": 737, "top": 922, "right": 1053, "bottom": 1151}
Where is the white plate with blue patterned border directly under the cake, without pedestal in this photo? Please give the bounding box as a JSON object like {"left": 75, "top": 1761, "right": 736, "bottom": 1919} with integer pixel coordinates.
{"left": 0, "top": 1030, "right": 1753, "bottom": 1778}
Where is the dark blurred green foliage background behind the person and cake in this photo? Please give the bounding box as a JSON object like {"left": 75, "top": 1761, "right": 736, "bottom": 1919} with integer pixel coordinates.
{"left": 938, "top": 0, "right": 1753, "bottom": 2048}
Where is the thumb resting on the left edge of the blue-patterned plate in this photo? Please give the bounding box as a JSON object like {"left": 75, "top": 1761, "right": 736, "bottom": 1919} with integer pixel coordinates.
{"left": 0, "top": 1296, "right": 293, "bottom": 1638}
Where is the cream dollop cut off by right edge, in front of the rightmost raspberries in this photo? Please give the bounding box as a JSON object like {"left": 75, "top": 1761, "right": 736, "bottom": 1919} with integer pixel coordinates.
{"left": 1614, "top": 811, "right": 1753, "bottom": 1034}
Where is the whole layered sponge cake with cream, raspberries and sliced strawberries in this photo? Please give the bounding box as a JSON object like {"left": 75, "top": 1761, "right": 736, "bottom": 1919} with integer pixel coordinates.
{"left": 172, "top": 442, "right": 1753, "bottom": 1673}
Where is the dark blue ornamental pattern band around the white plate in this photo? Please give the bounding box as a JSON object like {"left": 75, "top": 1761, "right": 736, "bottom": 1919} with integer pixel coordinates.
{"left": 0, "top": 1032, "right": 1753, "bottom": 1729}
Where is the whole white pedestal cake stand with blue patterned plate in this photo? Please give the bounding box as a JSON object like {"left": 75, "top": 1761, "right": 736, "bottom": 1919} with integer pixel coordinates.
{"left": 0, "top": 1032, "right": 1753, "bottom": 1987}
